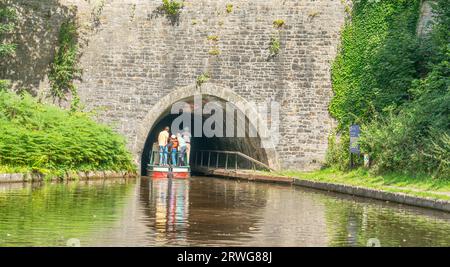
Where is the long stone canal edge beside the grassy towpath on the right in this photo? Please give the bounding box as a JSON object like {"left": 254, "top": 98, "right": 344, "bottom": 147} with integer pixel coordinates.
{"left": 198, "top": 168, "right": 450, "bottom": 212}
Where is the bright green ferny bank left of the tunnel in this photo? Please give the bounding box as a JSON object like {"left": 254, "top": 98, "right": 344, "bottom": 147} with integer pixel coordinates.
{"left": 0, "top": 91, "right": 134, "bottom": 176}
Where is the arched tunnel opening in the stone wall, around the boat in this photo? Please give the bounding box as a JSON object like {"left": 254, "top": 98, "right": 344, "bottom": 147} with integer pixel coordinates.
{"left": 141, "top": 94, "right": 270, "bottom": 176}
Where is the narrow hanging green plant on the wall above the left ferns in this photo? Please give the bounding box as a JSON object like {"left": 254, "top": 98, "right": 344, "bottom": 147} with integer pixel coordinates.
{"left": 48, "top": 21, "right": 80, "bottom": 110}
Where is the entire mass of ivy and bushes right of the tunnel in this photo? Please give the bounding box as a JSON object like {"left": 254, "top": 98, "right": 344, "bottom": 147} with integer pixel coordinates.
{"left": 329, "top": 0, "right": 450, "bottom": 178}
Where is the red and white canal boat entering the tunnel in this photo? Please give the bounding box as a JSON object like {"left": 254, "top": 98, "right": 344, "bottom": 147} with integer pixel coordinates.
{"left": 147, "top": 144, "right": 191, "bottom": 179}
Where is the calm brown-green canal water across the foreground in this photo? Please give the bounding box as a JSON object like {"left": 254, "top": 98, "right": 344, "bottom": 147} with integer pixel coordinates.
{"left": 0, "top": 177, "right": 450, "bottom": 246}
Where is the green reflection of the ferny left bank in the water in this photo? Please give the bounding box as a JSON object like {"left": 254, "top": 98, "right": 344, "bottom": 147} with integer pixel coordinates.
{"left": 0, "top": 182, "right": 134, "bottom": 246}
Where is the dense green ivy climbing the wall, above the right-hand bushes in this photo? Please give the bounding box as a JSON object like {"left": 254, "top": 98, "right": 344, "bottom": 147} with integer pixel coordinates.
{"left": 329, "top": 0, "right": 420, "bottom": 129}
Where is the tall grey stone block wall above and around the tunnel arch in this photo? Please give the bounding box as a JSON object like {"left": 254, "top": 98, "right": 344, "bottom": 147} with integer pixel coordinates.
{"left": 2, "top": 0, "right": 345, "bottom": 169}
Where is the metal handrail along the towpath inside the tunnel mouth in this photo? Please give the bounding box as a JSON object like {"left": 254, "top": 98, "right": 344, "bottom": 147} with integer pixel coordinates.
{"left": 191, "top": 150, "right": 275, "bottom": 171}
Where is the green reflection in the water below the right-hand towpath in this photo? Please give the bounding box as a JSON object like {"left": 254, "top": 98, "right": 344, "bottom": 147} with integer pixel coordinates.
{"left": 325, "top": 198, "right": 450, "bottom": 246}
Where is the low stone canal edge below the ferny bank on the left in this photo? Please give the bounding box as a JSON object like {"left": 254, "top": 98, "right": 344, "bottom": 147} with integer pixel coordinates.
{"left": 0, "top": 171, "right": 136, "bottom": 183}
